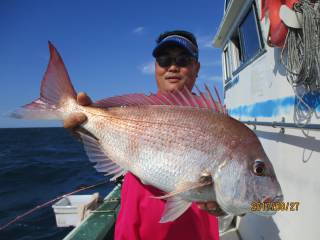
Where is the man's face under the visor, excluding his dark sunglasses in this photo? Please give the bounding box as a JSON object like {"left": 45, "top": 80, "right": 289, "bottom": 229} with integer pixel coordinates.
{"left": 155, "top": 46, "right": 200, "bottom": 92}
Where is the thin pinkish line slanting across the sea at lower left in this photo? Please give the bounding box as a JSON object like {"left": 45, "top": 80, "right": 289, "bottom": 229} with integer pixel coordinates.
{"left": 0, "top": 181, "right": 108, "bottom": 231}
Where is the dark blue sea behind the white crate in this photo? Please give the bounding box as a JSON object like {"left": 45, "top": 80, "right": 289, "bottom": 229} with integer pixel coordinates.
{"left": 0, "top": 128, "right": 114, "bottom": 240}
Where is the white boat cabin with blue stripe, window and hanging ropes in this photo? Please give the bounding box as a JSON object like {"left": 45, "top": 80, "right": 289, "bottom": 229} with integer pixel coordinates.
{"left": 213, "top": 0, "right": 320, "bottom": 240}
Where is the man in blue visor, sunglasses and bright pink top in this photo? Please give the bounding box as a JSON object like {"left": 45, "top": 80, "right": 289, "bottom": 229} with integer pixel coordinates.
{"left": 64, "top": 31, "right": 223, "bottom": 240}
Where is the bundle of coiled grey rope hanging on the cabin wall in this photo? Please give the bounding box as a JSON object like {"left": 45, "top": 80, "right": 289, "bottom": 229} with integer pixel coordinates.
{"left": 281, "top": 0, "right": 320, "bottom": 125}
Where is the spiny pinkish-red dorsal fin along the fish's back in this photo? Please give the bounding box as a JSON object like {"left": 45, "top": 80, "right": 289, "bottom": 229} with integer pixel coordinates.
{"left": 94, "top": 85, "right": 227, "bottom": 114}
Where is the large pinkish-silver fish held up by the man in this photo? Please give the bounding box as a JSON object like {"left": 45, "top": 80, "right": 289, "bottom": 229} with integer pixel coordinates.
{"left": 13, "top": 42, "right": 283, "bottom": 222}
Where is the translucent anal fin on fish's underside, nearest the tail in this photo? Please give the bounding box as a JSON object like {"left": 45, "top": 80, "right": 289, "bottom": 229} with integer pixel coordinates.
{"left": 77, "top": 130, "right": 125, "bottom": 181}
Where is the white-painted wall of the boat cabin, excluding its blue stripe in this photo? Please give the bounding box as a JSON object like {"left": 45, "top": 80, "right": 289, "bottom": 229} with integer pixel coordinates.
{"left": 218, "top": 1, "right": 320, "bottom": 240}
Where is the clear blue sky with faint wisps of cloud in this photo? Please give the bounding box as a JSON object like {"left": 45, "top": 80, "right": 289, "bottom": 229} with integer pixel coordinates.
{"left": 0, "top": 0, "right": 224, "bottom": 128}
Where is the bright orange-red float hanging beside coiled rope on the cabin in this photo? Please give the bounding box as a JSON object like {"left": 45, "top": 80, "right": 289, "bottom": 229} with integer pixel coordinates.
{"left": 261, "top": 0, "right": 299, "bottom": 47}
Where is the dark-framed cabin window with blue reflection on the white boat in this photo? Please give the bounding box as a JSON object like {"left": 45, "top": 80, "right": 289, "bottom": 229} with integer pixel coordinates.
{"left": 223, "top": 2, "right": 264, "bottom": 77}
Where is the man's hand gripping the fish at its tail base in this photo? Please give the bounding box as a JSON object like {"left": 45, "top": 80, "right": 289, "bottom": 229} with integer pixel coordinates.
{"left": 63, "top": 92, "right": 92, "bottom": 130}
